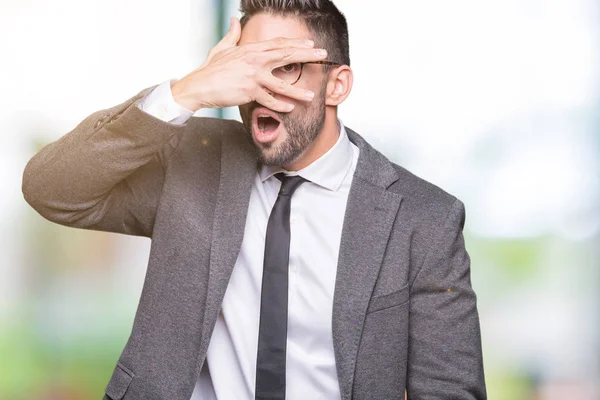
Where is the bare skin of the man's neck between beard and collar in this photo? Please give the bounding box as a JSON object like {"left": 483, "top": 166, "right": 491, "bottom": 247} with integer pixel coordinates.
{"left": 283, "top": 107, "right": 341, "bottom": 171}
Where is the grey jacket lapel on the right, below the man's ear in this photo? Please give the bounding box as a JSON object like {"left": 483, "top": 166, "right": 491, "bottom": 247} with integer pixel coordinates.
{"left": 332, "top": 128, "right": 402, "bottom": 400}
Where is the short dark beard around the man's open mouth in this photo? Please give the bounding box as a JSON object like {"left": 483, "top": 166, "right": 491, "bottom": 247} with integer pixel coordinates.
{"left": 239, "top": 85, "right": 327, "bottom": 166}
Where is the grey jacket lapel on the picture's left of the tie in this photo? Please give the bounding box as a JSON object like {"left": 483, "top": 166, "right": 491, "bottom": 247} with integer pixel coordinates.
{"left": 201, "top": 134, "right": 257, "bottom": 351}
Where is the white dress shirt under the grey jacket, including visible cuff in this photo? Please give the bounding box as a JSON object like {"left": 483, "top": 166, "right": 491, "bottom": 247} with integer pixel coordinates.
{"left": 139, "top": 81, "right": 359, "bottom": 400}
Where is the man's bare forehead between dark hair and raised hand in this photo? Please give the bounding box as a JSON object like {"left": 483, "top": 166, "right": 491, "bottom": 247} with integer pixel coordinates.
{"left": 238, "top": 13, "right": 312, "bottom": 45}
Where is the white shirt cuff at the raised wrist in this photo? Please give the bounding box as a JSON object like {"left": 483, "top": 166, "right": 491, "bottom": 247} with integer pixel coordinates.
{"left": 138, "top": 79, "right": 194, "bottom": 125}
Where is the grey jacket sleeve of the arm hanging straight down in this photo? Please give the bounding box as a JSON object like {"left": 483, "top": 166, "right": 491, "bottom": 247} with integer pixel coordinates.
{"left": 407, "top": 200, "right": 486, "bottom": 400}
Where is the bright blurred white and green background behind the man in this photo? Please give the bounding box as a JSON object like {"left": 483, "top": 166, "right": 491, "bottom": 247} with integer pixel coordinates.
{"left": 0, "top": 0, "right": 600, "bottom": 400}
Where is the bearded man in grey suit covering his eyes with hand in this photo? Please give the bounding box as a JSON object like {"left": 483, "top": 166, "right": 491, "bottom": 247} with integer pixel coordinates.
{"left": 23, "top": 0, "right": 486, "bottom": 400}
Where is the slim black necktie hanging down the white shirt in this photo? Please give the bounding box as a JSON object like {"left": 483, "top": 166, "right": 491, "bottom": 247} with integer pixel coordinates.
{"left": 255, "top": 173, "right": 306, "bottom": 400}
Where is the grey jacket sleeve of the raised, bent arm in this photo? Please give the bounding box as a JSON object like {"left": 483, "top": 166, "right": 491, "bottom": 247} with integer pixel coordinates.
{"left": 22, "top": 87, "right": 186, "bottom": 237}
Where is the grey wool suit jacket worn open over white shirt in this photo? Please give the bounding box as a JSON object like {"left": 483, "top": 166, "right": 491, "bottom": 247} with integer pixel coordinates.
{"left": 22, "top": 88, "right": 486, "bottom": 400}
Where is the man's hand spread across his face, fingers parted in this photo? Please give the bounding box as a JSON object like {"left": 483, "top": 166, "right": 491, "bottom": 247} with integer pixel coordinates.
{"left": 171, "top": 18, "right": 327, "bottom": 112}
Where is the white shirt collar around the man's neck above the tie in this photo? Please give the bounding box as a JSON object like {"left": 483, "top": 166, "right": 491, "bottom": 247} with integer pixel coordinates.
{"left": 260, "top": 118, "right": 353, "bottom": 191}
